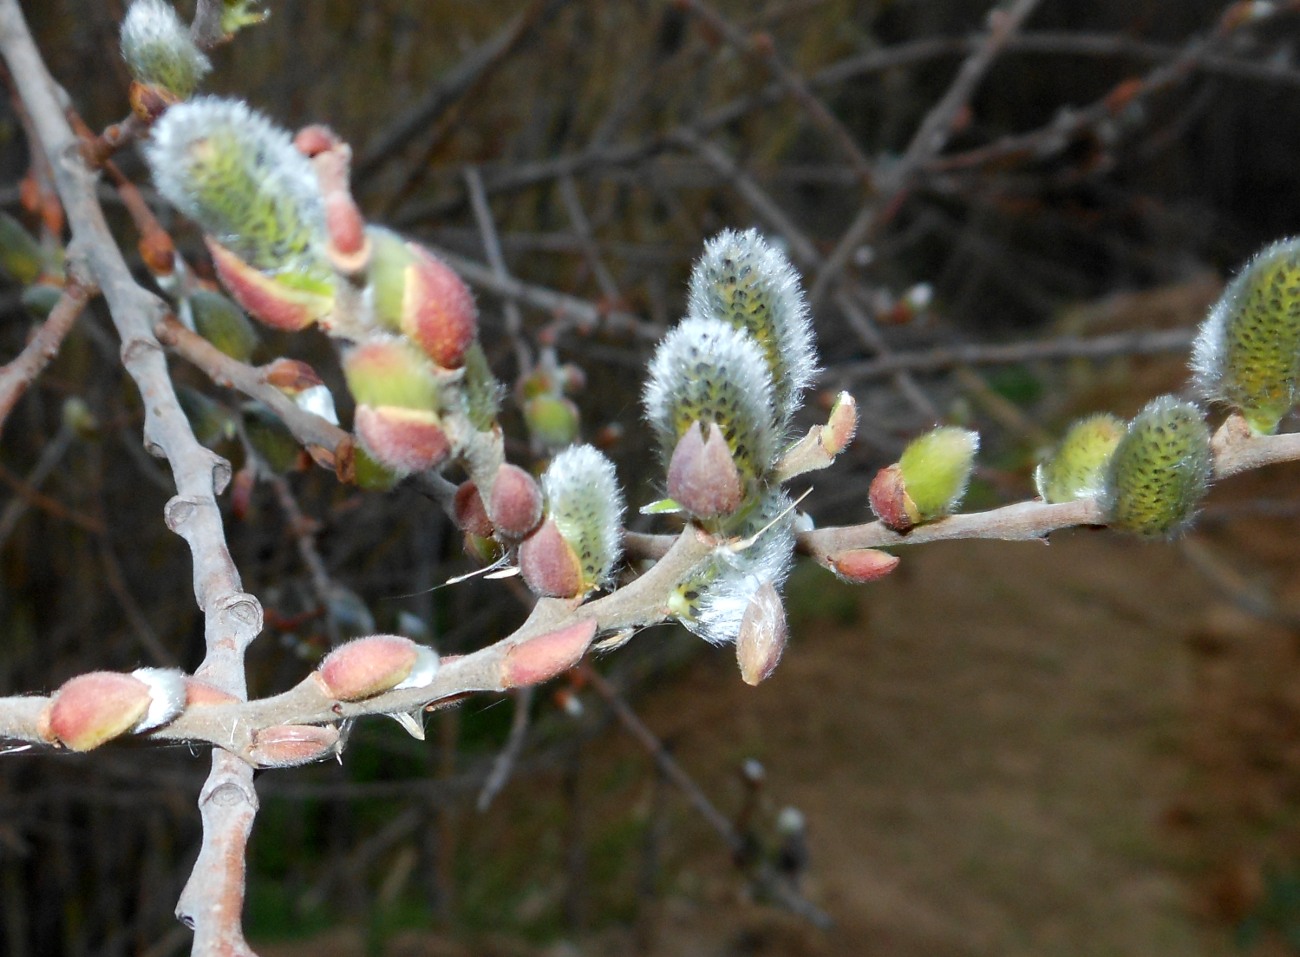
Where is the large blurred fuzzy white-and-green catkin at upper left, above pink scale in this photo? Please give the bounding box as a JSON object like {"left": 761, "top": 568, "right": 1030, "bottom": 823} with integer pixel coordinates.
{"left": 144, "top": 96, "right": 330, "bottom": 282}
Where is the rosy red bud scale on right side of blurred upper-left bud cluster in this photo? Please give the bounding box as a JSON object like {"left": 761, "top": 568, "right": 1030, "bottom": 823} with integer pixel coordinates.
{"left": 402, "top": 243, "right": 478, "bottom": 369}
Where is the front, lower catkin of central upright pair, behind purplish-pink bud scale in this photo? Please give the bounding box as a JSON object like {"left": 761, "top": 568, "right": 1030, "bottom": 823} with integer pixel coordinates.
{"left": 645, "top": 319, "right": 777, "bottom": 481}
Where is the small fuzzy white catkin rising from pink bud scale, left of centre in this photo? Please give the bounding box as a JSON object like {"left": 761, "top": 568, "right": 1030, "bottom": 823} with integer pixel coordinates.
{"left": 542, "top": 445, "right": 624, "bottom": 588}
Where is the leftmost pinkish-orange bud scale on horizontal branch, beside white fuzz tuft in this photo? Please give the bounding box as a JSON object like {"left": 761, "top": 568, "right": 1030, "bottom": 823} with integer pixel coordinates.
{"left": 43, "top": 671, "right": 153, "bottom": 752}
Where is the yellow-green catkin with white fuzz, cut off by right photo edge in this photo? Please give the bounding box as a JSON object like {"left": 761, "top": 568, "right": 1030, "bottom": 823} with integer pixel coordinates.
{"left": 1192, "top": 238, "right": 1300, "bottom": 434}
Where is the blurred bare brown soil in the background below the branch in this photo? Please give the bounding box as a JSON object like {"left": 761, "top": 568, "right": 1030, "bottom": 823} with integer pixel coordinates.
{"left": 258, "top": 504, "right": 1300, "bottom": 957}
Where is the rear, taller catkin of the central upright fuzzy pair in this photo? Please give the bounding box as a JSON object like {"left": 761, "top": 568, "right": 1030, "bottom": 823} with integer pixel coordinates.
{"left": 688, "top": 229, "right": 816, "bottom": 430}
